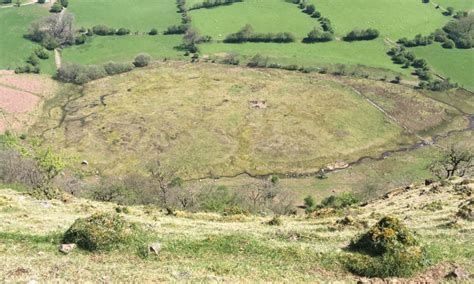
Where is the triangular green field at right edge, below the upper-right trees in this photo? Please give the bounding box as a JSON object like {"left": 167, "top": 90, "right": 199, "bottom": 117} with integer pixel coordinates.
{"left": 411, "top": 43, "right": 474, "bottom": 91}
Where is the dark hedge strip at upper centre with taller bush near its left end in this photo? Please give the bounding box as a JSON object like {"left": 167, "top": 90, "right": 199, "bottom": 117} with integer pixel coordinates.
{"left": 224, "top": 25, "right": 295, "bottom": 43}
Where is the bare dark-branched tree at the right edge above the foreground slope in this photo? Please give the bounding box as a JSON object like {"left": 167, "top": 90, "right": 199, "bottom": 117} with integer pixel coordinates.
{"left": 430, "top": 147, "right": 474, "bottom": 178}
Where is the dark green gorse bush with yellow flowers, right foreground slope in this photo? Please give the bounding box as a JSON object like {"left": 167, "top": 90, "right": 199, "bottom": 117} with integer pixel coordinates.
{"left": 345, "top": 216, "right": 429, "bottom": 277}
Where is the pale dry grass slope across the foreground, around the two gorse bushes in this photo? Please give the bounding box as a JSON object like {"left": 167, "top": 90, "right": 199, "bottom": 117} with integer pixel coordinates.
{"left": 0, "top": 181, "right": 474, "bottom": 283}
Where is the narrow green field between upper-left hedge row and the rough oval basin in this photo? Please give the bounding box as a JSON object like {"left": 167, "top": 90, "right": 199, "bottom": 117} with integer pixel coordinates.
{"left": 61, "top": 35, "right": 183, "bottom": 64}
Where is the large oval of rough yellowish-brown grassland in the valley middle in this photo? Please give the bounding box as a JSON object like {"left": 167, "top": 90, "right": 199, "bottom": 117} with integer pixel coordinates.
{"left": 33, "top": 62, "right": 468, "bottom": 181}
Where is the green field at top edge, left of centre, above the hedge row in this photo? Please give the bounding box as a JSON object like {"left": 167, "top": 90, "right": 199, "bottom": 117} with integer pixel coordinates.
{"left": 68, "top": 0, "right": 180, "bottom": 32}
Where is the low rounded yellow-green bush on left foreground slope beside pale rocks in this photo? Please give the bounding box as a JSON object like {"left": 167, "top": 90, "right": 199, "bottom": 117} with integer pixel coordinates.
{"left": 62, "top": 213, "right": 138, "bottom": 251}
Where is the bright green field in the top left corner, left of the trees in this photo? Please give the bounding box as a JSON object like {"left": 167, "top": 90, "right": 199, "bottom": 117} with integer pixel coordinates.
{"left": 0, "top": 5, "right": 48, "bottom": 69}
